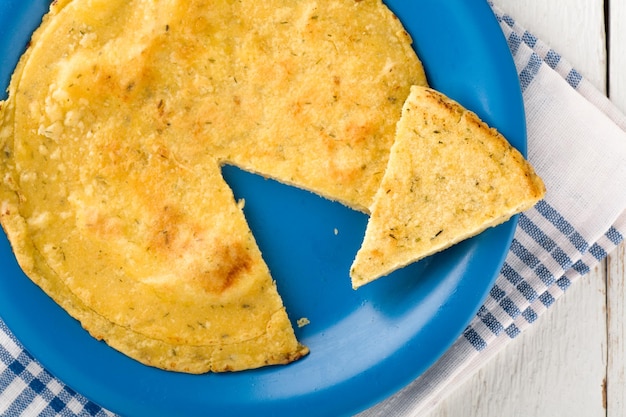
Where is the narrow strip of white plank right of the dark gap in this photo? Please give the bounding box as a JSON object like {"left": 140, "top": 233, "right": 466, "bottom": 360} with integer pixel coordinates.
{"left": 606, "top": 0, "right": 626, "bottom": 417}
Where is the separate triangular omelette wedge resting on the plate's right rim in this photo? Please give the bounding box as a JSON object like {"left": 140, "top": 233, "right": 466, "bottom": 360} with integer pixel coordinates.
{"left": 350, "top": 86, "right": 545, "bottom": 288}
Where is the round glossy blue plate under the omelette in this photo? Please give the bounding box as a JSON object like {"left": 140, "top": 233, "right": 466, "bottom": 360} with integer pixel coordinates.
{"left": 0, "top": 0, "right": 526, "bottom": 417}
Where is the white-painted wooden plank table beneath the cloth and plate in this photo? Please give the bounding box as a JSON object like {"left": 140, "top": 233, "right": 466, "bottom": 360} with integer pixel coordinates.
{"left": 425, "top": 0, "right": 626, "bottom": 417}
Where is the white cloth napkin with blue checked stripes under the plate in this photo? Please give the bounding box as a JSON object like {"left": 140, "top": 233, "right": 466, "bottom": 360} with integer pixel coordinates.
{"left": 0, "top": 4, "right": 626, "bottom": 417}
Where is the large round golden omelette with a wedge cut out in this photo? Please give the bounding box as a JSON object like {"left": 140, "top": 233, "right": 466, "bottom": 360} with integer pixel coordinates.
{"left": 0, "top": 0, "right": 425, "bottom": 373}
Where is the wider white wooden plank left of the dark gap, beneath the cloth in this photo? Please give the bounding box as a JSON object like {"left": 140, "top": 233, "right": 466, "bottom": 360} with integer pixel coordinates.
{"left": 428, "top": 0, "right": 608, "bottom": 417}
